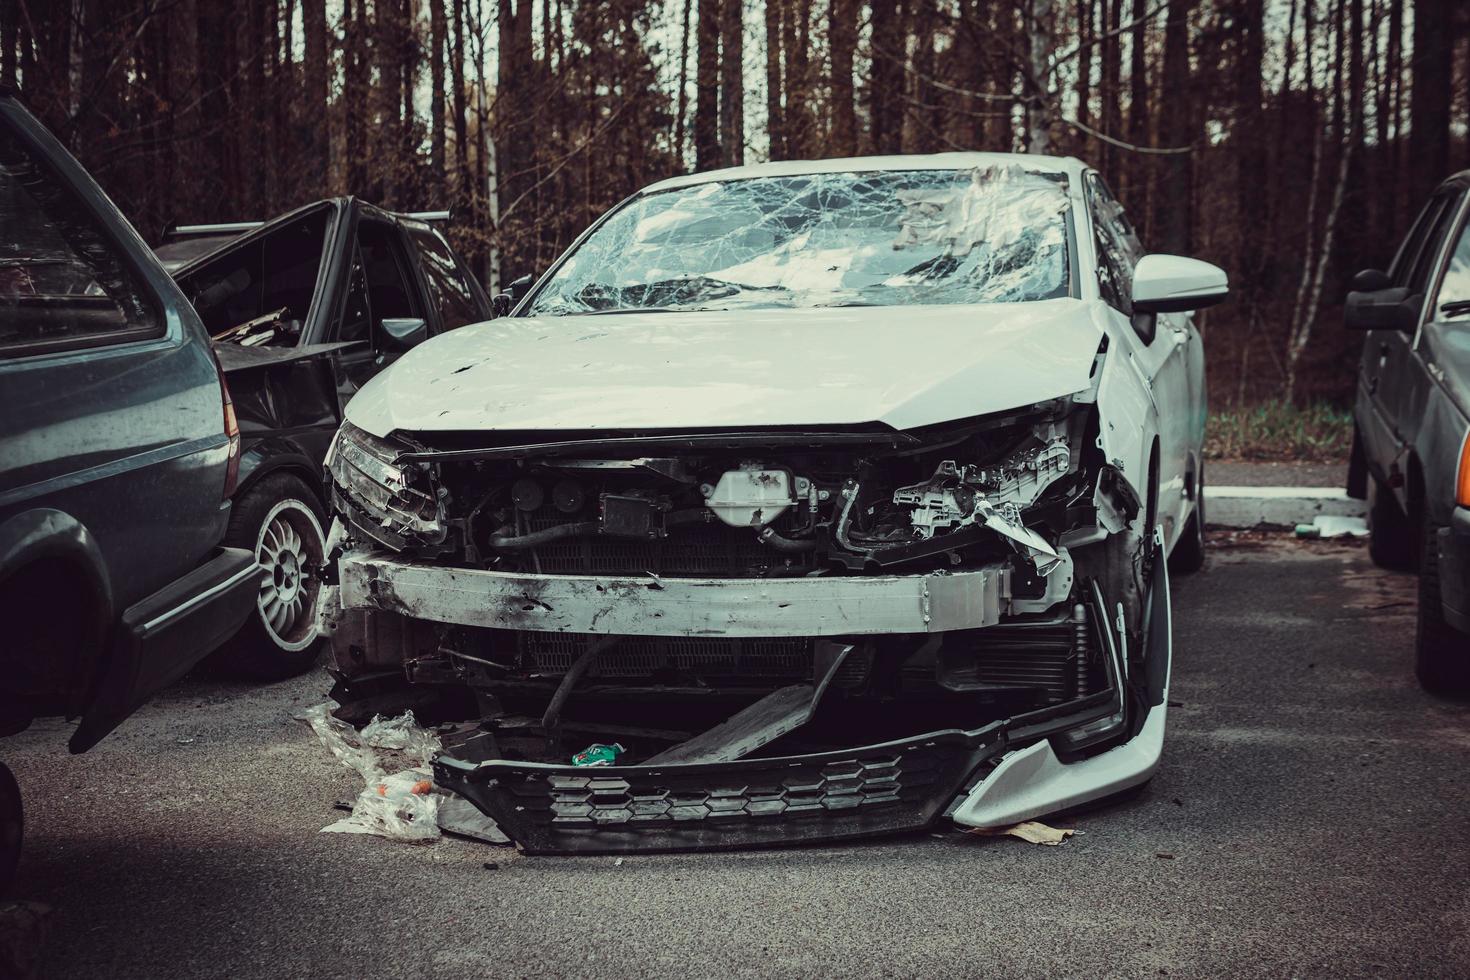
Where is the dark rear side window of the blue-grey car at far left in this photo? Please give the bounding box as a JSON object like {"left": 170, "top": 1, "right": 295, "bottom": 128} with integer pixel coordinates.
{"left": 0, "top": 123, "right": 163, "bottom": 357}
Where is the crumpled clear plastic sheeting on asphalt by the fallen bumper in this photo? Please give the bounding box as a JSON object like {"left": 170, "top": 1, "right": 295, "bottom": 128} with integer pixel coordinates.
{"left": 297, "top": 701, "right": 509, "bottom": 843}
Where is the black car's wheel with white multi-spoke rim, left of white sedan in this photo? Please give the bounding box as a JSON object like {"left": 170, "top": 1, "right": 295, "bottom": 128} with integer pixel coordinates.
{"left": 216, "top": 473, "right": 326, "bottom": 680}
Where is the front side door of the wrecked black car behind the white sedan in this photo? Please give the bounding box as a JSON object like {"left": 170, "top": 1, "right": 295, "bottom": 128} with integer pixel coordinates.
{"left": 334, "top": 213, "right": 429, "bottom": 407}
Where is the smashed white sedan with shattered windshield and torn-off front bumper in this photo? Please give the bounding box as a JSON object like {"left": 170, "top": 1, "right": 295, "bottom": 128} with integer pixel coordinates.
{"left": 323, "top": 153, "right": 1227, "bottom": 852}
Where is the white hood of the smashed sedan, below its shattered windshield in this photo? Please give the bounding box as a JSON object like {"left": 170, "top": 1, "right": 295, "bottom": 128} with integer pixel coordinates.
{"left": 347, "top": 300, "right": 1105, "bottom": 436}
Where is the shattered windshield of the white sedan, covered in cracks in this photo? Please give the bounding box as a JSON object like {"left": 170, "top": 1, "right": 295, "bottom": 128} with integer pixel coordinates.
{"left": 529, "top": 165, "right": 1072, "bottom": 316}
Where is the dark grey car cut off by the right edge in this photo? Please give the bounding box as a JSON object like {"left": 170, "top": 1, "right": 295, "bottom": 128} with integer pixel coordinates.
{"left": 1347, "top": 170, "right": 1470, "bottom": 693}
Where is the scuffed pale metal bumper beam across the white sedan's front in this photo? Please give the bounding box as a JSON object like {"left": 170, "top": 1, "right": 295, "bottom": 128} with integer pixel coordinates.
{"left": 338, "top": 554, "right": 1010, "bottom": 636}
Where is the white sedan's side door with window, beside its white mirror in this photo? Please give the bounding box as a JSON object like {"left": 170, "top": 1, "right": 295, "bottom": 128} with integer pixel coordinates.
{"left": 1086, "top": 173, "right": 1202, "bottom": 542}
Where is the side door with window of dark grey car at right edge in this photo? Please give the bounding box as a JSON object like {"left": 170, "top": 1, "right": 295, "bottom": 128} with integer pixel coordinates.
{"left": 1358, "top": 190, "right": 1464, "bottom": 487}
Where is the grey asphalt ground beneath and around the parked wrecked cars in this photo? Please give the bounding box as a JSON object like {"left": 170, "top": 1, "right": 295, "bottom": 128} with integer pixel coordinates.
{"left": 0, "top": 536, "right": 1470, "bottom": 979}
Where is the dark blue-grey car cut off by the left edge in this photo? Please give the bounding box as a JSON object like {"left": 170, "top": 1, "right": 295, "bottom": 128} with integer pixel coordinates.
{"left": 0, "top": 91, "right": 259, "bottom": 882}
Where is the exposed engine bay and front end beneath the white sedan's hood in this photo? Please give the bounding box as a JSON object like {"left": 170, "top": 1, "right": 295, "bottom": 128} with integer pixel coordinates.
{"left": 328, "top": 382, "right": 1154, "bottom": 849}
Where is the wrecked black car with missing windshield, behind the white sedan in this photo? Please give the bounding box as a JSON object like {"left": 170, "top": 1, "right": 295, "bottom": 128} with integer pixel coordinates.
{"left": 156, "top": 197, "right": 491, "bottom": 679}
